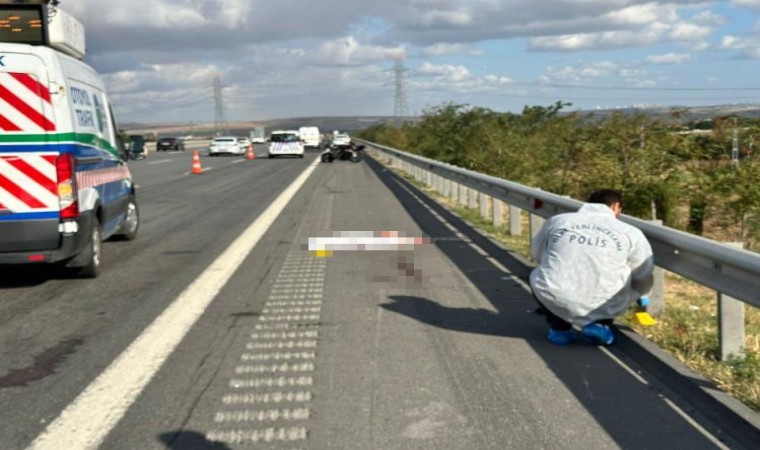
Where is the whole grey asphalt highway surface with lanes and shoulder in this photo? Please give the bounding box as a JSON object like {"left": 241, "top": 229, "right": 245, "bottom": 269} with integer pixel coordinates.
{"left": 0, "top": 147, "right": 757, "bottom": 450}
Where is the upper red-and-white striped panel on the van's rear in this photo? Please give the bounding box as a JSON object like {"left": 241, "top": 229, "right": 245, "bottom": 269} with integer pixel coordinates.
{"left": 0, "top": 72, "right": 56, "bottom": 133}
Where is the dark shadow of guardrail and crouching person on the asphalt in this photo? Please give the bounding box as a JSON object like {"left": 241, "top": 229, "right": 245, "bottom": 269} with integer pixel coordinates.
{"left": 366, "top": 158, "right": 760, "bottom": 449}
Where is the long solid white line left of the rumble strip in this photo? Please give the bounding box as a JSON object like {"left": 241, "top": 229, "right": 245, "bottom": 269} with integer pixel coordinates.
{"left": 29, "top": 160, "right": 319, "bottom": 450}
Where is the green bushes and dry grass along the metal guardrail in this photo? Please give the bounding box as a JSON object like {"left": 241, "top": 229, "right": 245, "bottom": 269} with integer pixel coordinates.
{"left": 361, "top": 102, "right": 760, "bottom": 411}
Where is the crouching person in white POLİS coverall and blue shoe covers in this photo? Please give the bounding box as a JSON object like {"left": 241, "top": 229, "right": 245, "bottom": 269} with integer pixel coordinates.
{"left": 530, "top": 189, "right": 654, "bottom": 345}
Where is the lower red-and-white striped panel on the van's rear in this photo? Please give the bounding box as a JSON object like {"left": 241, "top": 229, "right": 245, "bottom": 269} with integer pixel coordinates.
{"left": 0, "top": 153, "right": 60, "bottom": 212}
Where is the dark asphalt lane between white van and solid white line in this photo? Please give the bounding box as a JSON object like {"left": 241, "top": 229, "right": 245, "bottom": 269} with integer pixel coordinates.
{"left": 0, "top": 154, "right": 318, "bottom": 446}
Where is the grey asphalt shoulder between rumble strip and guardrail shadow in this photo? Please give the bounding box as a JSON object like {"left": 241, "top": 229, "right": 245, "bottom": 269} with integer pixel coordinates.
{"left": 294, "top": 162, "right": 609, "bottom": 449}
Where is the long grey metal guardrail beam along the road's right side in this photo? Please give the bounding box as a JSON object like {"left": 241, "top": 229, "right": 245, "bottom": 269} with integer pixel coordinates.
{"left": 357, "top": 139, "right": 760, "bottom": 355}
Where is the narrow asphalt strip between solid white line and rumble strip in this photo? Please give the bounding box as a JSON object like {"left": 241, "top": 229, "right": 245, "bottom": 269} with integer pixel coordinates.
{"left": 101, "top": 158, "right": 330, "bottom": 449}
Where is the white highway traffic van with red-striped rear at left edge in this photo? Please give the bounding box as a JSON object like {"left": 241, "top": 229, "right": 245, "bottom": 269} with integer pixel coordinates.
{"left": 0, "top": 4, "right": 139, "bottom": 277}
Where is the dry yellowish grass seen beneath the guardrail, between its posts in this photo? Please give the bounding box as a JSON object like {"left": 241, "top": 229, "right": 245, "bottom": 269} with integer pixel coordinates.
{"left": 394, "top": 164, "right": 760, "bottom": 412}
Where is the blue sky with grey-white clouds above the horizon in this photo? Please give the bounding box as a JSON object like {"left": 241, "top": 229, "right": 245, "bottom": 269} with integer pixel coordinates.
{"left": 60, "top": 0, "right": 760, "bottom": 123}
